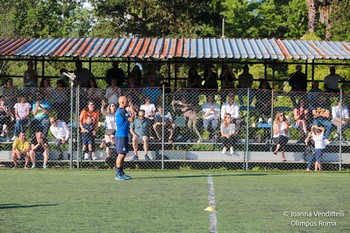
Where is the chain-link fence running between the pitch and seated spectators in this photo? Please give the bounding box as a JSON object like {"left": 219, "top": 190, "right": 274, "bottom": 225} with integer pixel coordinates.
{"left": 0, "top": 85, "right": 350, "bottom": 170}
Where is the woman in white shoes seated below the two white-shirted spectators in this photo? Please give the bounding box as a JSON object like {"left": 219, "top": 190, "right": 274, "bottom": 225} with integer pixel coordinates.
{"left": 220, "top": 113, "right": 237, "bottom": 155}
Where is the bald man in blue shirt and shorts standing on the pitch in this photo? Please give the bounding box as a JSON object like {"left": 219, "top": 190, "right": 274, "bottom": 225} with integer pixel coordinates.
{"left": 115, "top": 96, "right": 135, "bottom": 180}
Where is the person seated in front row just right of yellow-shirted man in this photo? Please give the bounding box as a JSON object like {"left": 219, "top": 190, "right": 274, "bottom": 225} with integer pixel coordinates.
{"left": 29, "top": 132, "right": 49, "bottom": 169}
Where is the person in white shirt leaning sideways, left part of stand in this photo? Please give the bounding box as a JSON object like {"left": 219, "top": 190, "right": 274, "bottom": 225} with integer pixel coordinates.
{"left": 50, "top": 117, "right": 70, "bottom": 160}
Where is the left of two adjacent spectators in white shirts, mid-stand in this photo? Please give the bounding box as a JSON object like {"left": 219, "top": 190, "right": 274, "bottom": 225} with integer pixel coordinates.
{"left": 202, "top": 95, "right": 220, "bottom": 140}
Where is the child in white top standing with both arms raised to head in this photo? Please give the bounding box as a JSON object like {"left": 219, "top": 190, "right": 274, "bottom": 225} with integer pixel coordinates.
{"left": 305, "top": 125, "right": 326, "bottom": 171}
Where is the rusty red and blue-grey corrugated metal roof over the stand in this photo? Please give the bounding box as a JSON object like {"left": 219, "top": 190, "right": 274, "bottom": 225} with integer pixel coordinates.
{"left": 0, "top": 37, "right": 350, "bottom": 60}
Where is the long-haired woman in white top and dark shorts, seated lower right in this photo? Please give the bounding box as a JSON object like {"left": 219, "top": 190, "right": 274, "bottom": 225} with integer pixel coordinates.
{"left": 273, "top": 112, "right": 290, "bottom": 161}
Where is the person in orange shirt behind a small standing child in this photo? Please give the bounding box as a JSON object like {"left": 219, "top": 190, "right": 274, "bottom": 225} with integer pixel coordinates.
{"left": 79, "top": 100, "right": 100, "bottom": 160}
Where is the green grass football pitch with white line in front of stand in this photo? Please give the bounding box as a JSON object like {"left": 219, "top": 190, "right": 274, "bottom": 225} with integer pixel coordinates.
{"left": 0, "top": 169, "right": 350, "bottom": 233}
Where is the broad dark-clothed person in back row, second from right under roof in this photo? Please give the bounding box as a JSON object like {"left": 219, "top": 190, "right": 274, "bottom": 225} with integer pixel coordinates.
{"left": 288, "top": 65, "right": 307, "bottom": 106}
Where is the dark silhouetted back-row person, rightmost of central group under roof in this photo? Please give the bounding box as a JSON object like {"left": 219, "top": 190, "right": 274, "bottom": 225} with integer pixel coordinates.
{"left": 238, "top": 65, "right": 254, "bottom": 106}
